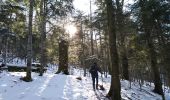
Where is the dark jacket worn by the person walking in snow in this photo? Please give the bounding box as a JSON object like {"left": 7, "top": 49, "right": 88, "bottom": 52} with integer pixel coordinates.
{"left": 89, "top": 64, "right": 101, "bottom": 77}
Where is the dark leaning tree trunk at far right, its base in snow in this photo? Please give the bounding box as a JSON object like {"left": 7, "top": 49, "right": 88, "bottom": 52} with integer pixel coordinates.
{"left": 139, "top": 0, "right": 165, "bottom": 100}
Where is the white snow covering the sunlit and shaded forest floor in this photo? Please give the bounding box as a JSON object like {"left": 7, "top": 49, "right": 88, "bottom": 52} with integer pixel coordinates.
{"left": 0, "top": 68, "right": 170, "bottom": 100}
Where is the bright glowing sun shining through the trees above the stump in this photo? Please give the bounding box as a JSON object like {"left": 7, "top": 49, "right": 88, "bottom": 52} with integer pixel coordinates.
{"left": 65, "top": 24, "right": 77, "bottom": 37}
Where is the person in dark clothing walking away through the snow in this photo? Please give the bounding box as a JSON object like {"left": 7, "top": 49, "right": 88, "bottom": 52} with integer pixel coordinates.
{"left": 89, "top": 62, "right": 102, "bottom": 90}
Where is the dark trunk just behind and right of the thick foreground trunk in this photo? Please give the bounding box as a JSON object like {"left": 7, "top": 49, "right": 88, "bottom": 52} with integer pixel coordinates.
{"left": 116, "top": 0, "right": 129, "bottom": 80}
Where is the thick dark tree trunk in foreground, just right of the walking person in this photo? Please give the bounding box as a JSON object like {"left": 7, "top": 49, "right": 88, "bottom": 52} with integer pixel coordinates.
{"left": 105, "top": 0, "right": 121, "bottom": 100}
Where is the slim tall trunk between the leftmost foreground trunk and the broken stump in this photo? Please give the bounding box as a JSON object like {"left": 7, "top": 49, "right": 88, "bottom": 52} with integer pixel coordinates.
{"left": 39, "top": 0, "right": 46, "bottom": 76}
